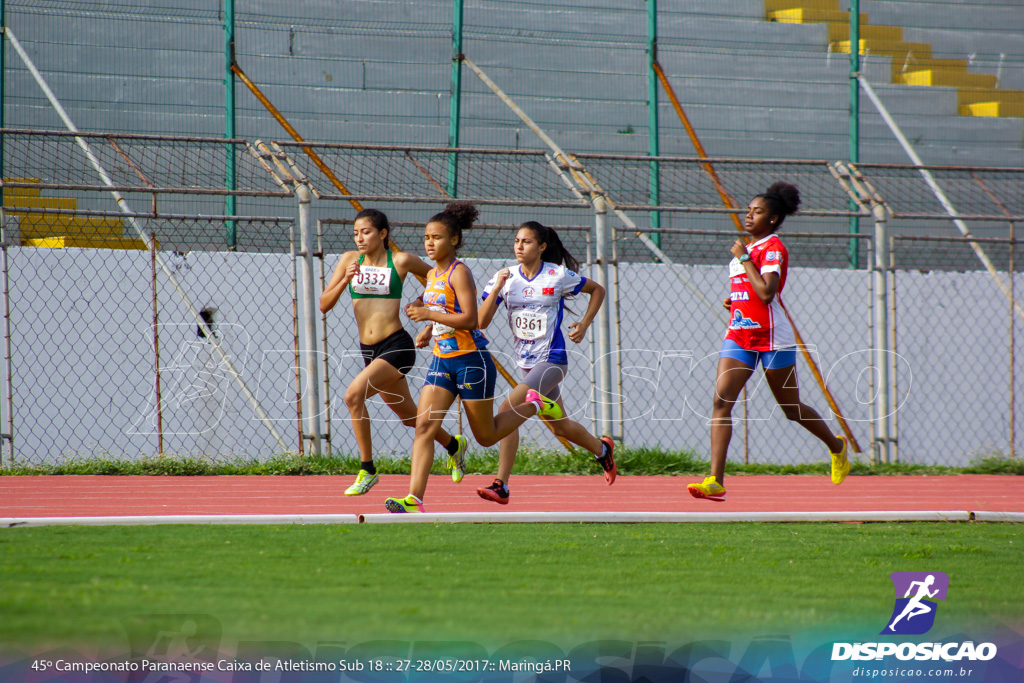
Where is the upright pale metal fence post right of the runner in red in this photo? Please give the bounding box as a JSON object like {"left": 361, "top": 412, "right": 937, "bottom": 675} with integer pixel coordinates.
{"left": 871, "top": 201, "right": 892, "bottom": 463}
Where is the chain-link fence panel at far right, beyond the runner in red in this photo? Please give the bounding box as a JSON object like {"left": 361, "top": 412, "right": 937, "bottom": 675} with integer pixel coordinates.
{"left": 891, "top": 237, "right": 1024, "bottom": 462}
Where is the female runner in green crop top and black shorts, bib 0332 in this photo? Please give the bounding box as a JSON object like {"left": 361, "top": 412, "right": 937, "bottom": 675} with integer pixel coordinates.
{"left": 321, "top": 209, "right": 469, "bottom": 496}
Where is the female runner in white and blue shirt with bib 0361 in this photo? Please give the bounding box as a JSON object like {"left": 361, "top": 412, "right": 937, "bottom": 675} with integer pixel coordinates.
{"left": 476, "top": 220, "right": 618, "bottom": 505}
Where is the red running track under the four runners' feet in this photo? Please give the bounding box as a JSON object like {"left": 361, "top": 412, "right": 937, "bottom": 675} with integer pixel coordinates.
{"left": 0, "top": 474, "right": 1024, "bottom": 517}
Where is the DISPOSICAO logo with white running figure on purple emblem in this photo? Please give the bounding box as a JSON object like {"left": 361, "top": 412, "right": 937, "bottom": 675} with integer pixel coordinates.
{"left": 831, "top": 571, "right": 996, "bottom": 661}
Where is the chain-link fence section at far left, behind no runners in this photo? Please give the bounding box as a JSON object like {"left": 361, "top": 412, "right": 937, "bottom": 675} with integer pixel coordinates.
{"left": 4, "top": 208, "right": 298, "bottom": 463}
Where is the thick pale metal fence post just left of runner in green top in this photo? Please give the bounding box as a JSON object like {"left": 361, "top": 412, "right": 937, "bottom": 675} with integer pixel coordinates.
{"left": 295, "top": 182, "right": 322, "bottom": 455}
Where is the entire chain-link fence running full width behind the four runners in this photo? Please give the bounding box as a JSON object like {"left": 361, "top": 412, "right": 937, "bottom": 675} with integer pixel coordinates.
{"left": 0, "top": 130, "right": 1024, "bottom": 464}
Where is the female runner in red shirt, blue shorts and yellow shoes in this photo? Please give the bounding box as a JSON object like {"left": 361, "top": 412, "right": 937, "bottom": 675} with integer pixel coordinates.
{"left": 686, "top": 182, "right": 850, "bottom": 501}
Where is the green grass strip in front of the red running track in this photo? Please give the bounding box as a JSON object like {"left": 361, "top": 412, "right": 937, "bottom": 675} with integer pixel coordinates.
{"left": 0, "top": 523, "right": 1024, "bottom": 648}
